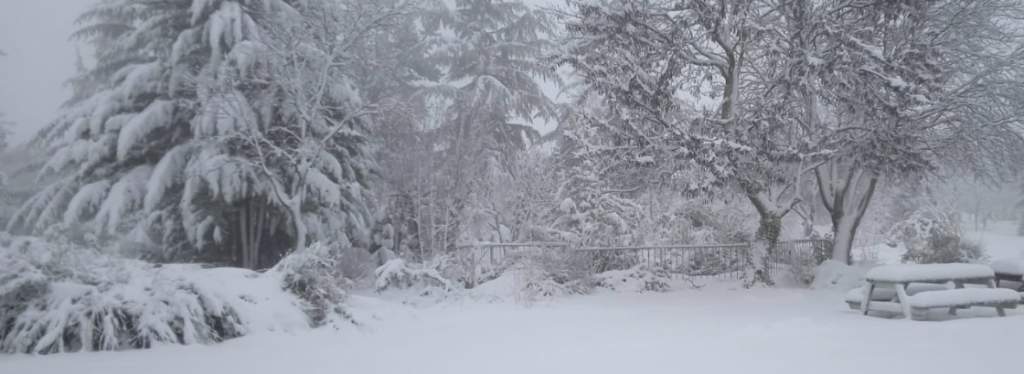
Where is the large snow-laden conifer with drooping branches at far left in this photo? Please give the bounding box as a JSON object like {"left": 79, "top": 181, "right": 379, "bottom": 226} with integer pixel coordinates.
{"left": 9, "top": 0, "right": 387, "bottom": 267}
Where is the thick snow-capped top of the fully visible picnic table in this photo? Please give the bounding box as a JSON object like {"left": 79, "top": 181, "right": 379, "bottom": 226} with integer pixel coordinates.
{"left": 864, "top": 263, "right": 995, "bottom": 283}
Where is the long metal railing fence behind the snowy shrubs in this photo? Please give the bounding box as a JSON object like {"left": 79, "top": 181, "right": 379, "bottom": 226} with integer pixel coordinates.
{"left": 463, "top": 240, "right": 828, "bottom": 279}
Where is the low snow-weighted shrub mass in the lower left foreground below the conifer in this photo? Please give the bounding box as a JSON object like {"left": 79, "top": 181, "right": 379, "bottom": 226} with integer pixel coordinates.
{"left": 0, "top": 238, "right": 310, "bottom": 354}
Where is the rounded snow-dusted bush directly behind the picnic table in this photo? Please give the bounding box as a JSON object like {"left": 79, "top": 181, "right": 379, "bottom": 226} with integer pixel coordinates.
{"left": 888, "top": 209, "right": 985, "bottom": 263}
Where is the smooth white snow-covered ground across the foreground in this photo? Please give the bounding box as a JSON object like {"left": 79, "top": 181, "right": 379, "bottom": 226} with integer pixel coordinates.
{"left": 0, "top": 223, "right": 1024, "bottom": 374}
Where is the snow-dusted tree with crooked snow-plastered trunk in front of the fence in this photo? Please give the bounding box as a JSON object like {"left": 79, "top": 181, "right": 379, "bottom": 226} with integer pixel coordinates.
{"left": 554, "top": 0, "right": 814, "bottom": 286}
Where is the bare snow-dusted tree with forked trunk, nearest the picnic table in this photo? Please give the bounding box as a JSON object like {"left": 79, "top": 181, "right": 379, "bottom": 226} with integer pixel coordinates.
{"left": 772, "top": 0, "right": 1024, "bottom": 262}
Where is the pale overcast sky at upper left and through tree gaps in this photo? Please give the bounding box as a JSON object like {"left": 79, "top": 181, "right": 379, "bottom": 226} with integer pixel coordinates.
{"left": 0, "top": 0, "right": 559, "bottom": 147}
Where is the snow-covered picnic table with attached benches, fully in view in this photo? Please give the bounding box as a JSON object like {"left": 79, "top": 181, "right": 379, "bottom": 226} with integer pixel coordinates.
{"left": 847, "top": 263, "right": 1021, "bottom": 320}
